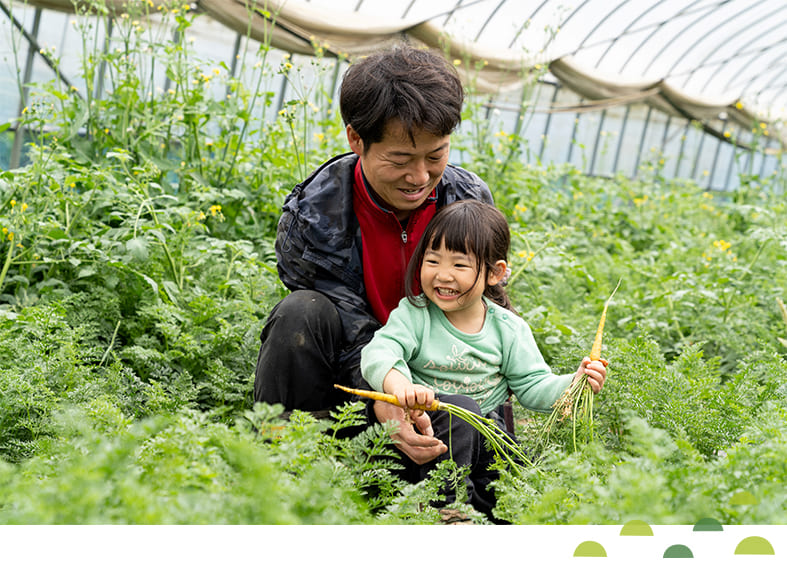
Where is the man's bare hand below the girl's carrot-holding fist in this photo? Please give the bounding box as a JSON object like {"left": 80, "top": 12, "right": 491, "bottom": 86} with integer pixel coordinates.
{"left": 374, "top": 401, "right": 448, "bottom": 466}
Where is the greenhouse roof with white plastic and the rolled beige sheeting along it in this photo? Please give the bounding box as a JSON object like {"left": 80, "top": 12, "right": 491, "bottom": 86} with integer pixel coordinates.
{"left": 21, "top": 0, "right": 787, "bottom": 143}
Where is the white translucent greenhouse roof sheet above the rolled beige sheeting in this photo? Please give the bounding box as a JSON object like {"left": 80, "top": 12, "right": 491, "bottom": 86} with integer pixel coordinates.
{"left": 298, "top": 0, "right": 787, "bottom": 122}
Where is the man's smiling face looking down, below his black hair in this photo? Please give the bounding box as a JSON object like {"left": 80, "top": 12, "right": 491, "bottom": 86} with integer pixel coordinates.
{"left": 347, "top": 122, "right": 450, "bottom": 220}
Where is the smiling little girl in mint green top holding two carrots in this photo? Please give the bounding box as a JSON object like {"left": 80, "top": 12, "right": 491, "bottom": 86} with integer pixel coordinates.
{"left": 361, "top": 200, "right": 606, "bottom": 517}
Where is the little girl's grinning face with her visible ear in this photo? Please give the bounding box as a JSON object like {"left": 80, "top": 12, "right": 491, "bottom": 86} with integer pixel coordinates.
{"left": 421, "top": 242, "right": 506, "bottom": 333}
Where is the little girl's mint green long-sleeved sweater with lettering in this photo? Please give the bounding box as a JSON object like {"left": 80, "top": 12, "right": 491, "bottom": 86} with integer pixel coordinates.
{"left": 361, "top": 298, "right": 574, "bottom": 414}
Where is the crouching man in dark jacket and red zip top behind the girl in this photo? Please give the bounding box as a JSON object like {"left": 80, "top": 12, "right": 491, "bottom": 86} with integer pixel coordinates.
{"left": 254, "top": 45, "right": 492, "bottom": 463}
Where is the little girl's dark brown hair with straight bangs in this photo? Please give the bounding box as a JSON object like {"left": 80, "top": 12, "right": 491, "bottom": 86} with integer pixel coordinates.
{"left": 405, "top": 200, "right": 514, "bottom": 311}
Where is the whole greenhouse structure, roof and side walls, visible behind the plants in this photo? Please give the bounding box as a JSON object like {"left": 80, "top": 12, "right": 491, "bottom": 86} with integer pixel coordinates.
{"left": 0, "top": 0, "right": 787, "bottom": 190}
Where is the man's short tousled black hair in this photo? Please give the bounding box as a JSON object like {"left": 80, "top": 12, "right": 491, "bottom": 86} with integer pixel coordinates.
{"left": 339, "top": 43, "right": 464, "bottom": 148}
